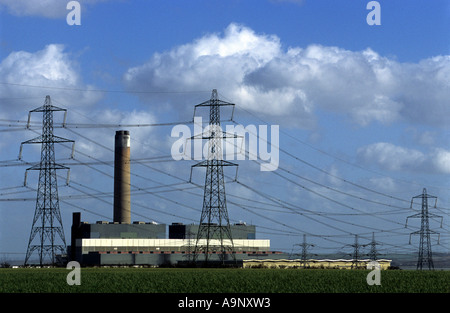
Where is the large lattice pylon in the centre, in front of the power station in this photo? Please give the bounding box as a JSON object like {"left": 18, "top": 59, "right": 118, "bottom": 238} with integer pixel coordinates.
{"left": 192, "top": 89, "right": 237, "bottom": 265}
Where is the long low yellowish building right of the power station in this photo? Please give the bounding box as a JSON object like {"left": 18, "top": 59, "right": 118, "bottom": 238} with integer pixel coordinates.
{"left": 243, "top": 258, "right": 392, "bottom": 270}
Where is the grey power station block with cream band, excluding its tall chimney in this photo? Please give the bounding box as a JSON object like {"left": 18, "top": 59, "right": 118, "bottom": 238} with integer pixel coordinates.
{"left": 70, "top": 212, "right": 287, "bottom": 266}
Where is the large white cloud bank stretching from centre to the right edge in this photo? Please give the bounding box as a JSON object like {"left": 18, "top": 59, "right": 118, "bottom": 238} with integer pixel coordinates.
{"left": 124, "top": 23, "right": 450, "bottom": 128}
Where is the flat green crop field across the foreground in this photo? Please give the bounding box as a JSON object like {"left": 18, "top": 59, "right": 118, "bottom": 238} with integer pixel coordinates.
{"left": 0, "top": 268, "right": 450, "bottom": 293}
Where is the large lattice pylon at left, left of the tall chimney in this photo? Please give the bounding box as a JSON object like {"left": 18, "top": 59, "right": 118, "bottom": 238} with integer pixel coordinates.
{"left": 19, "top": 96, "right": 74, "bottom": 265}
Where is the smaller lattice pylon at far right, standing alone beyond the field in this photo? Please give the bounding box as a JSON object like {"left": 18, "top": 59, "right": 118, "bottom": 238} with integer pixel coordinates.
{"left": 405, "top": 188, "right": 442, "bottom": 270}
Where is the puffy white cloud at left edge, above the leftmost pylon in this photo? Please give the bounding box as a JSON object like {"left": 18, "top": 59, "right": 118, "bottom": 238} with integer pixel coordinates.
{"left": 0, "top": 44, "right": 101, "bottom": 111}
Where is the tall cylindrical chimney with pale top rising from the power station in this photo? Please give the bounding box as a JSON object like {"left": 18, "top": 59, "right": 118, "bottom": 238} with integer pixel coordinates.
{"left": 114, "top": 130, "right": 131, "bottom": 224}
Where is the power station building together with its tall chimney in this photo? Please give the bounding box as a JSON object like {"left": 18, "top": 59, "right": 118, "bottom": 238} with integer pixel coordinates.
{"left": 69, "top": 131, "right": 287, "bottom": 266}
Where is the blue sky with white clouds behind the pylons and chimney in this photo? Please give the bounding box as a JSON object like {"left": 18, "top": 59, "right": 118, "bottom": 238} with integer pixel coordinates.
{"left": 0, "top": 0, "right": 450, "bottom": 259}
